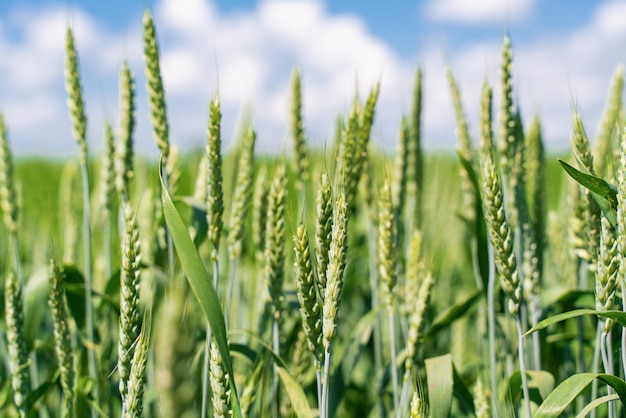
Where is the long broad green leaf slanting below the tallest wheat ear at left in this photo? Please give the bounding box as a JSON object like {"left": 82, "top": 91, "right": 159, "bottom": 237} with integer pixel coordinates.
{"left": 159, "top": 161, "right": 241, "bottom": 418}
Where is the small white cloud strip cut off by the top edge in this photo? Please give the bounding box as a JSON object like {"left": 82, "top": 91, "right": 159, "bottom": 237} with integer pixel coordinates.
{"left": 426, "top": 0, "right": 534, "bottom": 24}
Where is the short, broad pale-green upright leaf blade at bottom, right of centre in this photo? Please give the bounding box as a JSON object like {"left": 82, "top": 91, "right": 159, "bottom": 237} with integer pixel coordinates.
{"left": 426, "top": 354, "right": 454, "bottom": 418}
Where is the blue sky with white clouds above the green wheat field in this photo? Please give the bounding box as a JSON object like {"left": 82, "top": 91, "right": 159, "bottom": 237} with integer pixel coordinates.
{"left": 0, "top": 0, "right": 626, "bottom": 156}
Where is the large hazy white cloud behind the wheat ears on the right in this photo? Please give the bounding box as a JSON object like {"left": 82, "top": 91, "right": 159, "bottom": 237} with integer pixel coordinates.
{"left": 424, "top": 2, "right": 626, "bottom": 150}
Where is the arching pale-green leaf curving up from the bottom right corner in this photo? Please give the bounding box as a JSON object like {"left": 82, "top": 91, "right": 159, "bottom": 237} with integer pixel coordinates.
{"left": 534, "top": 373, "right": 626, "bottom": 418}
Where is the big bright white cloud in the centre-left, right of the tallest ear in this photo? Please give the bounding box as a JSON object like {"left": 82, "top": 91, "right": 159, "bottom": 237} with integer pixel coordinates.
{"left": 147, "top": 0, "right": 408, "bottom": 150}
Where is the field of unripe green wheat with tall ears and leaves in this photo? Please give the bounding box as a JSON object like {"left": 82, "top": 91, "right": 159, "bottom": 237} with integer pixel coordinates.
{"left": 0, "top": 12, "right": 626, "bottom": 418}
